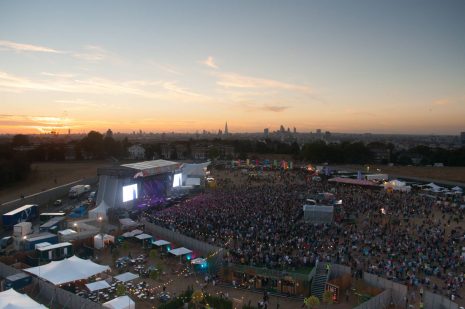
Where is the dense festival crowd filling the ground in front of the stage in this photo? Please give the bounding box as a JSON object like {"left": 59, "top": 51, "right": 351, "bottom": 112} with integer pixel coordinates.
{"left": 143, "top": 171, "right": 465, "bottom": 298}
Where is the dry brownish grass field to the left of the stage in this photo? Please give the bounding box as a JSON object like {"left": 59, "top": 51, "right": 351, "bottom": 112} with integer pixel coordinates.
{"left": 0, "top": 161, "right": 108, "bottom": 204}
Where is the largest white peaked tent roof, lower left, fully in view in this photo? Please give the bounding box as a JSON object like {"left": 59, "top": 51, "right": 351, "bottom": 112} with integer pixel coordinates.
{"left": 24, "top": 256, "right": 110, "bottom": 285}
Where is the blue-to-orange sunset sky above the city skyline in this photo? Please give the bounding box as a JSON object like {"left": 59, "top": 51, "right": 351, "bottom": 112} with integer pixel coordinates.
{"left": 0, "top": 0, "right": 465, "bottom": 135}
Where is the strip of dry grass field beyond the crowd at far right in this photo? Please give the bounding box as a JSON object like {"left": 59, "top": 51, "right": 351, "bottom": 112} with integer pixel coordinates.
{"left": 341, "top": 165, "right": 465, "bottom": 183}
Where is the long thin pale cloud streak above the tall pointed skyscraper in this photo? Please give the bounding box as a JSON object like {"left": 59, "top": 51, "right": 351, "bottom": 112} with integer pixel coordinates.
{"left": 214, "top": 73, "right": 312, "bottom": 94}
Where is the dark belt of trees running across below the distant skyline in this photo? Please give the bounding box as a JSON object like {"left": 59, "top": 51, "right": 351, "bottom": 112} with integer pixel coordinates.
{"left": 0, "top": 130, "right": 465, "bottom": 186}
